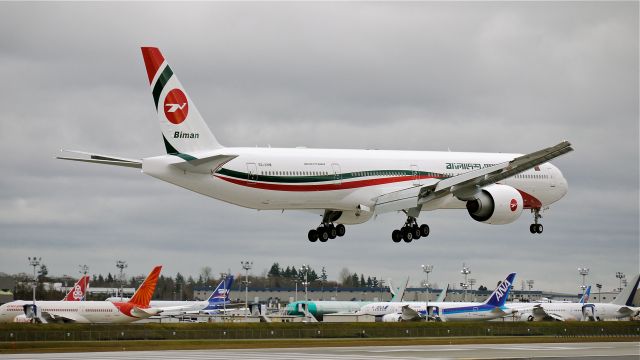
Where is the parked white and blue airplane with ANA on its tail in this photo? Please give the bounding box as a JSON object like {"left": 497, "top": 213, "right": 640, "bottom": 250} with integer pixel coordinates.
{"left": 358, "top": 273, "right": 516, "bottom": 322}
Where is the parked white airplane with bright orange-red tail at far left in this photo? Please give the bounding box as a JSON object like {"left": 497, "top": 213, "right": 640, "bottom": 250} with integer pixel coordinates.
{"left": 0, "top": 266, "right": 162, "bottom": 323}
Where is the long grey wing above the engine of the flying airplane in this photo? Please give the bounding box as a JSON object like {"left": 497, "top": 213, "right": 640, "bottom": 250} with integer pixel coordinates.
{"left": 375, "top": 141, "right": 573, "bottom": 213}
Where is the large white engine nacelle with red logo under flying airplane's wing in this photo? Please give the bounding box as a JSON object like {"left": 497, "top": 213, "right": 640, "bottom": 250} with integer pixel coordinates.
{"left": 467, "top": 184, "right": 524, "bottom": 225}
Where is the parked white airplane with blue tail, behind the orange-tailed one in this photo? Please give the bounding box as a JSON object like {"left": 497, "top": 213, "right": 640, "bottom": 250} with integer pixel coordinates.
{"left": 107, "top": 275, "right": 233, "bottom": 316}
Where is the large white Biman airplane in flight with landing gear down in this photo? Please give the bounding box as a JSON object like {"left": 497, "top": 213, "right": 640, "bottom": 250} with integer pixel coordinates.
{"left": 58, "top": 47, "right": 573, "bottom": 242}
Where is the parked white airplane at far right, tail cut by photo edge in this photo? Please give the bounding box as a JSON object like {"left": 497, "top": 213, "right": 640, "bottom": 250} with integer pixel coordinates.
{"left": 507, "top": 274, "right": 640, "bottom": 321}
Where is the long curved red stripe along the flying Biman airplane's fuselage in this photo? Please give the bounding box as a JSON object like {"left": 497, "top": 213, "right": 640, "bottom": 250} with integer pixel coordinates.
{"left": 215, "top": 175, "right": 431, "bottom": 191}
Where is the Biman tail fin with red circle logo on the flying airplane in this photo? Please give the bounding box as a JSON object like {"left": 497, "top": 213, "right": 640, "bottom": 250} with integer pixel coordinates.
{"left": 142, "top": 47, "right": 222, "bottom": 156}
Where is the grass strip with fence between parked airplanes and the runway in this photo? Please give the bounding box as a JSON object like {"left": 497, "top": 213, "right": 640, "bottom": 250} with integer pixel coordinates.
{"left": 0, "top": 322, "right": 640, "bottom": 353}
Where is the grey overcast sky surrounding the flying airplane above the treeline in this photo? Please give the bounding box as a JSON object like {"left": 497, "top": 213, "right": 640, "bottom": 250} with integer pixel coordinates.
{"left": 0, "top": 2, "right": 640, "bottom": 293}
